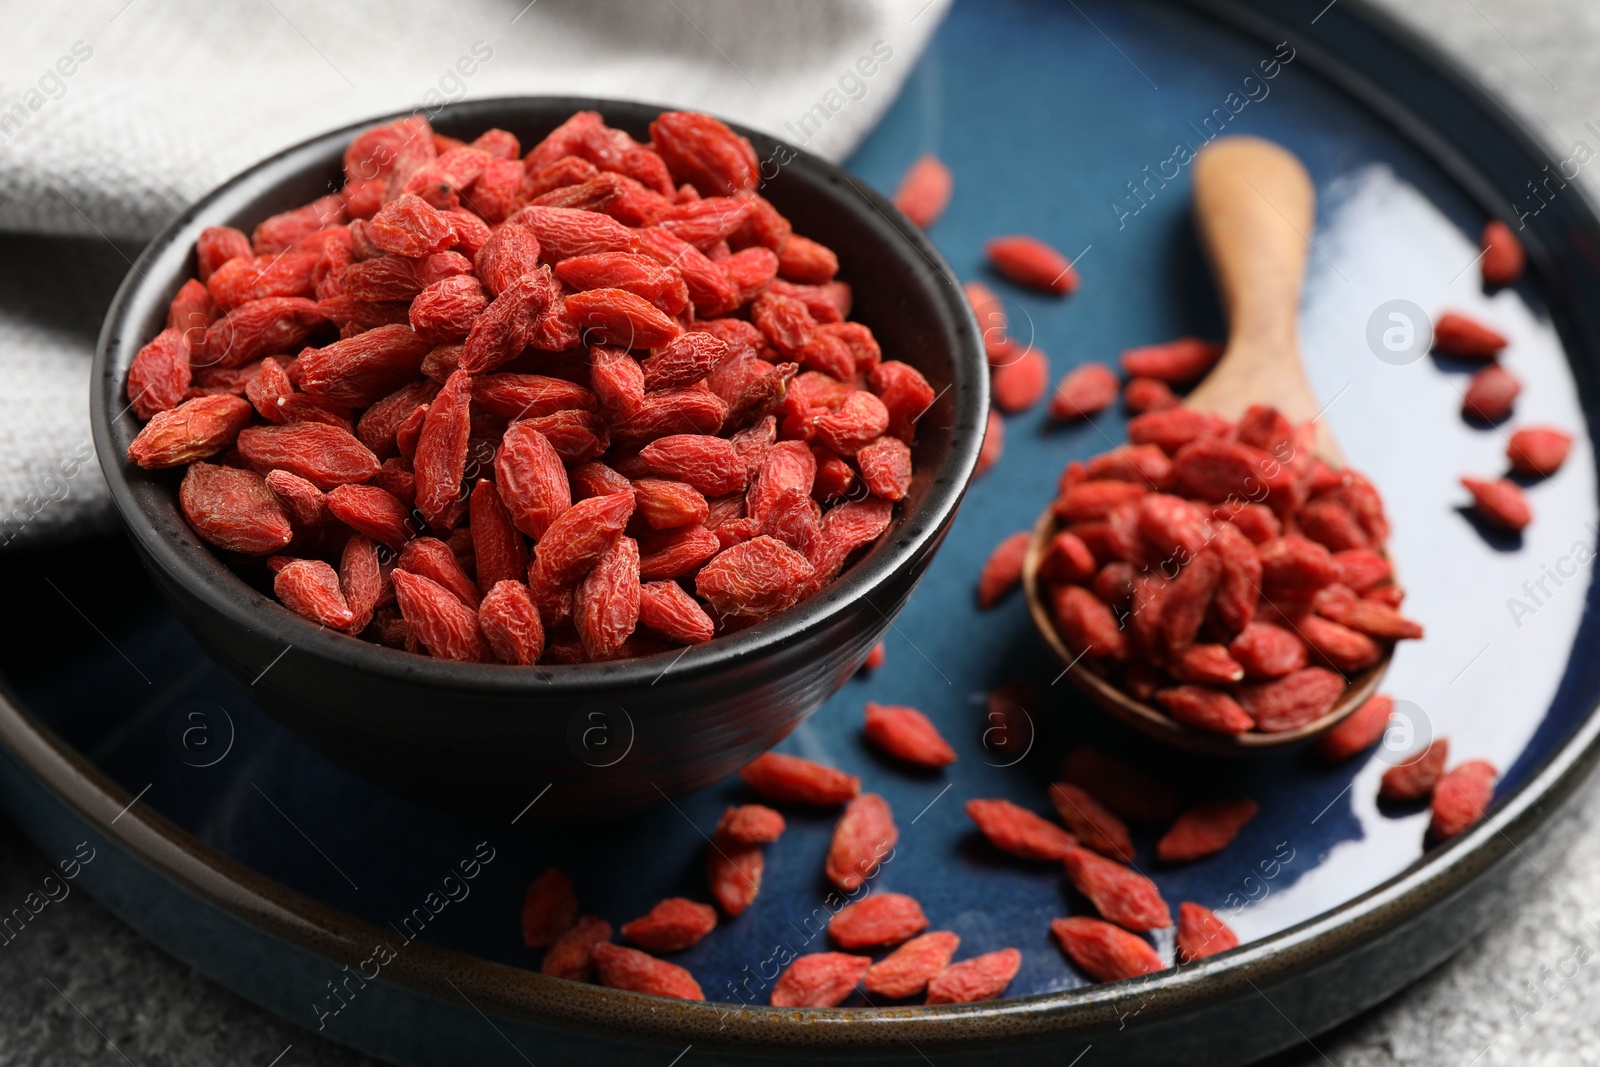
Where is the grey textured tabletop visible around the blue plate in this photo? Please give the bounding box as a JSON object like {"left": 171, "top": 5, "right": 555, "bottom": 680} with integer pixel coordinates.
{"left": 0, "top": 0, "right": 1600, "bottom": 1067}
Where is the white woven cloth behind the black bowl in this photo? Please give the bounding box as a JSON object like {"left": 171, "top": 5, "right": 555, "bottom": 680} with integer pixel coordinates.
{"left": 0, "top": 0, "right": 949, "bottom": 545}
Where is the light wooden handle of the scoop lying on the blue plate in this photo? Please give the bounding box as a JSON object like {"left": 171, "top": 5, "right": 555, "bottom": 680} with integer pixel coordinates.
{"left": 1189, "top": 136, "right": 1334, "bottom": 453}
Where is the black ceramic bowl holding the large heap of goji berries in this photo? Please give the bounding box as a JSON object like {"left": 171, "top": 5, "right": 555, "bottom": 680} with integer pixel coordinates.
{"left": 91, "top": 98, "right": 989, "bottom": 821}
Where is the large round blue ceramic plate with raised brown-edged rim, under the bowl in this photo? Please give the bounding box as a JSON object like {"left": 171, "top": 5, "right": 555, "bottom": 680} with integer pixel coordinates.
{"left": 0, "top": 0, "right": 1600, "bottom": 1067}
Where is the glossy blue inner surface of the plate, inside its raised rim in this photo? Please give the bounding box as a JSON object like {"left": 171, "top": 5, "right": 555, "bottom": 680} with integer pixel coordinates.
{"left": 0, "top": 0, "right": 1600, "bottom": 1062}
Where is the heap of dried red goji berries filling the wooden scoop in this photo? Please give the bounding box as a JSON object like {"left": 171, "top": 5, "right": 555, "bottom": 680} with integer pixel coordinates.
{"left": 979, "top": 398, "right": 1422, "bottom": 734}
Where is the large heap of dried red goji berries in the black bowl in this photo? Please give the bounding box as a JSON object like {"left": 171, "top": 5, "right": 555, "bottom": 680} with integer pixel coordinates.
{"left": 128, "top": 112, "right": 934, "bottom": 664}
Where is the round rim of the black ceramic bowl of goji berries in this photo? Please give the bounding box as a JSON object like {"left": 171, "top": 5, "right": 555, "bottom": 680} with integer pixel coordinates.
{"left": 90, "top": 94, "right": 989, "bottom": 696}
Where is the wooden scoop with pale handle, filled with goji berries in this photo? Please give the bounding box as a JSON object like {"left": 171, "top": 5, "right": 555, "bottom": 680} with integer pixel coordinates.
{"left": 1022, "top": 136, "right": 1394, "bottom": 755}
